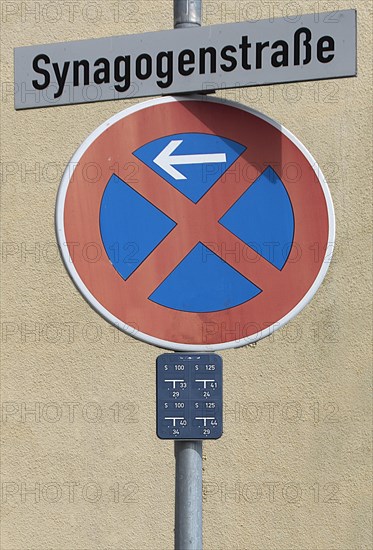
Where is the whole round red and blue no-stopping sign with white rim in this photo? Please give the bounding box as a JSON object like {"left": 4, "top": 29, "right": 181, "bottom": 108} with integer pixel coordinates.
{"left": 56, "top": 96, "right": 334, "bottom": 351}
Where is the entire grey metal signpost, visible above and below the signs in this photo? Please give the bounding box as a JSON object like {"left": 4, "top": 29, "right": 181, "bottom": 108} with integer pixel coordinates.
{"left": 174, "top": 0, "right": 202, "bottom": 550}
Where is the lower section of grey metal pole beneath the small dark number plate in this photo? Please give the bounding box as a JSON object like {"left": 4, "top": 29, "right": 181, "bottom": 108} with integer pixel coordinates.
{"left": 175, "top": 441, "right": 202, "bottom": 550}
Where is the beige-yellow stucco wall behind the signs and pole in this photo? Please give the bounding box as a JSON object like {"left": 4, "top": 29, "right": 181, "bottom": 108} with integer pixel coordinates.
{"left": 0, "top": 0, "right": 372, "bottom": 550}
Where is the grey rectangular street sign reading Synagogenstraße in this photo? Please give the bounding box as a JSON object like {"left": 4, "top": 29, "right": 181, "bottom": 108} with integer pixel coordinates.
{"left": 14, "top": 10, "right": 356, "bottom": 109}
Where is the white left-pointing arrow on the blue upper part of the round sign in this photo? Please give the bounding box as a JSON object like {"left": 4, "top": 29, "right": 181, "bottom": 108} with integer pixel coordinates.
{"left": 154, "top": 139, "right": 227, "bottom": 180}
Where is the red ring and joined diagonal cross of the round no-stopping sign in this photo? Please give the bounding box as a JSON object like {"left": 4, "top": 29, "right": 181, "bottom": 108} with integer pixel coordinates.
{"left": 64, "top": 100, "right": 329, "bottom": 347}
